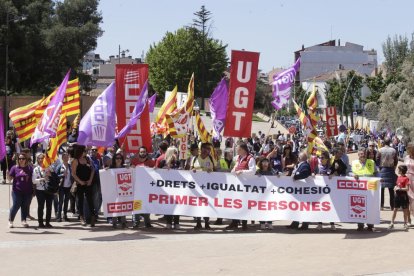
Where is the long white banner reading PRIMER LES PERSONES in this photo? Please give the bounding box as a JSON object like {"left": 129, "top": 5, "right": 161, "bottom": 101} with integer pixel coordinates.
{"left": 100, "top": 167, "right": 380, "bottom": 224}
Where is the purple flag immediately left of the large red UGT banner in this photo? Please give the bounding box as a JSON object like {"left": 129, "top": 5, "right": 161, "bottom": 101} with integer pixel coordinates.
{"left": 210, "top": 78, "right": 229, "bottom": 139}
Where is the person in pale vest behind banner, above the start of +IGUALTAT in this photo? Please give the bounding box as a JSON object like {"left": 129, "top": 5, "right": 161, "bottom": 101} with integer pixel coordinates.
{"left": 190, "top": 143, "right": 216, "bottom": 230}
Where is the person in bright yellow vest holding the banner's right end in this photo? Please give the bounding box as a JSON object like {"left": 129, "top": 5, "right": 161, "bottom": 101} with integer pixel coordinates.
{"left": 351, "top": 148, "right": 375, "bottom": 232}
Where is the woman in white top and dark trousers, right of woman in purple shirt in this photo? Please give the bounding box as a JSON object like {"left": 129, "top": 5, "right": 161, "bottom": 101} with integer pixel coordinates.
{"left": 32, "top": 153, "right": 53, "bottom": 228}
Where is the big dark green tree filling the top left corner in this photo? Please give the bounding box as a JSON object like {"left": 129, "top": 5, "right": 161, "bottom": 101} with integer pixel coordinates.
{"left": 0, "top": 0, "right": 102, "bottom": 94}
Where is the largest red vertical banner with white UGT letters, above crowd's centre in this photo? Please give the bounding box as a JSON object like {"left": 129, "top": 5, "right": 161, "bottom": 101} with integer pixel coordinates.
{"left": 224, "top": 50, "right": 259, "bottom": 137}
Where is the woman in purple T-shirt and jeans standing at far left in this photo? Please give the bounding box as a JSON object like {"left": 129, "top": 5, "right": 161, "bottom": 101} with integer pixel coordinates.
{"left": 8, "top": 154, "right": 33, "bottom": 228}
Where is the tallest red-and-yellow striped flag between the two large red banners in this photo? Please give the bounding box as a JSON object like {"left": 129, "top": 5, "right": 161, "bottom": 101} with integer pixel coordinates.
{"left": 165, "top": 73, "right": 194, "bottom": 138}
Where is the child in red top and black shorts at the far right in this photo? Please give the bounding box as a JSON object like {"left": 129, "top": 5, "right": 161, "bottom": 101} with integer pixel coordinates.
{"left": 389, "top": 165, "right": 410, "bottom": 230}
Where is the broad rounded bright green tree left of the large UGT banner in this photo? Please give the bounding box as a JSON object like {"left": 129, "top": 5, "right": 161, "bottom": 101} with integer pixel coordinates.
{"left": 146, "top": 27, "right": 228, "bottom": 101}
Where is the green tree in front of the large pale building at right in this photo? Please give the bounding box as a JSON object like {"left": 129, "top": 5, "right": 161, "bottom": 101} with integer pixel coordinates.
{"left": 326, "top": 70, "right": 363, "bottom": 128}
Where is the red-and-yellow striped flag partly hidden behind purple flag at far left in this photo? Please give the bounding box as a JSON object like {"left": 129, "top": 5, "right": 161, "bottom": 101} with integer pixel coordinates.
{"left": 10, "top": 78, "right": 80, "bottom": 142}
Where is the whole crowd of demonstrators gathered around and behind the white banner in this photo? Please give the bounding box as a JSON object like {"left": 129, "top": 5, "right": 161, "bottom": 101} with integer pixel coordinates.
{"left": 2, "top": 129, "right": 414, "bottom": 231}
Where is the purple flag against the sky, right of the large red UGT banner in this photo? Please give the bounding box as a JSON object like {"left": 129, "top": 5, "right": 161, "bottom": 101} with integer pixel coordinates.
{"left": 272, "top": 58, "right": 300, "bottom": 110}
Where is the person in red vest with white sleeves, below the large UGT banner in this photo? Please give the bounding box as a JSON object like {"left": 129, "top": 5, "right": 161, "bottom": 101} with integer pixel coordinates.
{"left": 225, "top": 142, "right": 256, "bottom": 231}
